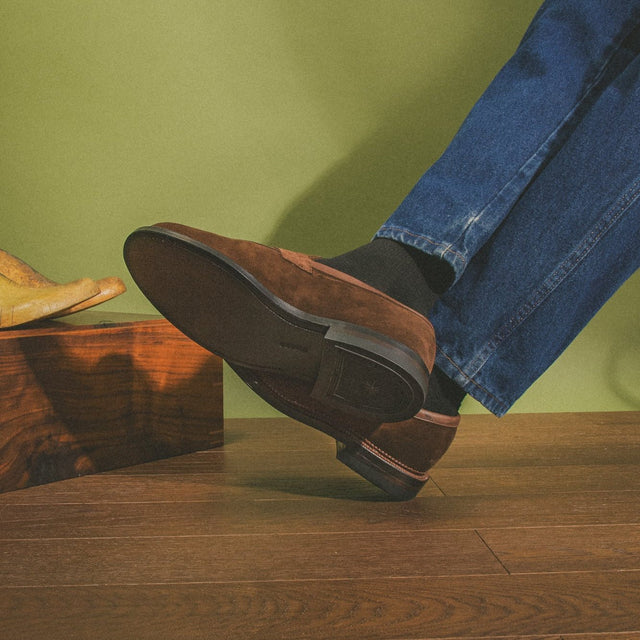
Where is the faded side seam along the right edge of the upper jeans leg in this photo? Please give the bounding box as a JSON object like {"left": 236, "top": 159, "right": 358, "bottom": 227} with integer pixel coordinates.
{"left": 443, "top": 23, "right": 638, "bottom": 264}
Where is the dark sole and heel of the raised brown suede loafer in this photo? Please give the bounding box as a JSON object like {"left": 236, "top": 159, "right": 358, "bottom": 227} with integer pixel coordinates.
{"left": 124, "top": 227, "right": 429, "bottom": 422}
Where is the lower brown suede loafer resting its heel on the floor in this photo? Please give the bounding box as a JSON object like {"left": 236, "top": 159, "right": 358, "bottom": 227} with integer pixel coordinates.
{"left": 233, "top": 366, "right": 460, "bottom": 500}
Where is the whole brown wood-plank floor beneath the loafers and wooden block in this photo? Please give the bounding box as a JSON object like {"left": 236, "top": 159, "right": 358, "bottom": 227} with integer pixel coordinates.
{"left": 0, "top": 412, "right": 640, "bottom": 640}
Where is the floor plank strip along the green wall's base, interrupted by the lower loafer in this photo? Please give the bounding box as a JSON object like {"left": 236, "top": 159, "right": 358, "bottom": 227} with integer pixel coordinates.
{"left": 220, "top": 411, "right": 640, "bottom": 467}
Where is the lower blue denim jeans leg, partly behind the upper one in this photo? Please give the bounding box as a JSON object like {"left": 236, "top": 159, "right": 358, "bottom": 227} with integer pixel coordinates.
{"left": 431, "top": 45, "right": 640, "bottom": 415}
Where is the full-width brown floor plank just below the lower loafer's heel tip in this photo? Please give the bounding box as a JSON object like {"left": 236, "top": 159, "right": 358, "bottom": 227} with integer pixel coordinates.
{"left": 0, "top": 491, "right": 640, "bottom": 539}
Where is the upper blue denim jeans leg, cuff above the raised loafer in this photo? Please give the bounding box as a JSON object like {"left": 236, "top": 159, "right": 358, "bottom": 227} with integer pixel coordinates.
{"left": 377, "top": 0, "right": 640, "bottom": 277}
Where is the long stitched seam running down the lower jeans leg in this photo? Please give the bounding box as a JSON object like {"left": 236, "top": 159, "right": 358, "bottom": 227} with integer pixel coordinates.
{"left": 469, "top": 172, "right": 640, "bottom": 373}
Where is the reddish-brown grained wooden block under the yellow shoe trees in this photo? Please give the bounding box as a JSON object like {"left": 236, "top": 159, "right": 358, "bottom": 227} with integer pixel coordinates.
{"left": 0, "top": 311, "right": 223, "bottom": 491}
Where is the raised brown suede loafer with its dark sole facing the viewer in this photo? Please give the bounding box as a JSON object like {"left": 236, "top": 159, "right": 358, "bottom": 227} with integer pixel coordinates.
{"left": 124, "top": 223, "right": 435, "bottom": 423}
